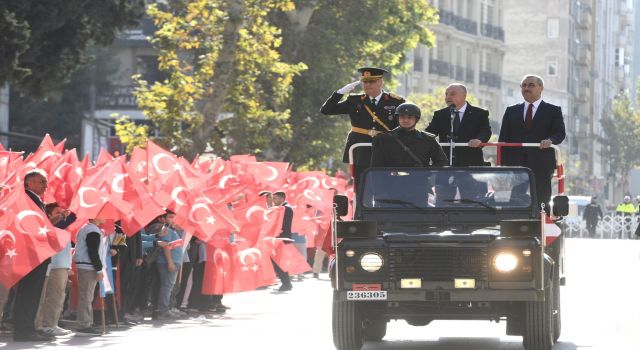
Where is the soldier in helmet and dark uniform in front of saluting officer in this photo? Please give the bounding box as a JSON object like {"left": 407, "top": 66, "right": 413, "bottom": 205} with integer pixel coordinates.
{"left": 371, "top": 103, "right": 448, "bottom": 167}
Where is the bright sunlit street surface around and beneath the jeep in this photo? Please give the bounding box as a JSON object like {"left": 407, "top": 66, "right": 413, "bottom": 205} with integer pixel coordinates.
{"left": 0, "top": 239, "right": 640, "bottom": 350}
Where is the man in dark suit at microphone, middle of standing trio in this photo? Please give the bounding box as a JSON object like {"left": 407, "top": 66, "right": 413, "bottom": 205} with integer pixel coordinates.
{"left": 426, "top": 84, "right": 491, "bottom": 166}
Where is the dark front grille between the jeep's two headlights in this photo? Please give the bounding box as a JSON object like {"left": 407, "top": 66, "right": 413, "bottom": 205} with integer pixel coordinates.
{"left": 387, "top": 247, "right": 488, "bottom": 281}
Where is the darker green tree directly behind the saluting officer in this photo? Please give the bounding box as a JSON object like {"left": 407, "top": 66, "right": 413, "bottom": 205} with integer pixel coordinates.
{"left": 272, "top": 0, "right": 437, "bottom": 168}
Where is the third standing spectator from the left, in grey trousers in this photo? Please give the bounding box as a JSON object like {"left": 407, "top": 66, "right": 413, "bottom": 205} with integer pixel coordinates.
{"left": 74, "top": 219, "right": 106, "bottom": 335}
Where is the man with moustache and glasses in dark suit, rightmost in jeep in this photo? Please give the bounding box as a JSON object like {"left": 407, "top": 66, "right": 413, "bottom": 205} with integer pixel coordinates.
{"left": 498, "top": 75, "right": 566, "bottom": 213}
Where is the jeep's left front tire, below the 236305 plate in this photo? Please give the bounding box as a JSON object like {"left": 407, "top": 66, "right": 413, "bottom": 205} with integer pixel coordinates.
{"left": 332, "top": 291, "right": 362, "bottom": 350}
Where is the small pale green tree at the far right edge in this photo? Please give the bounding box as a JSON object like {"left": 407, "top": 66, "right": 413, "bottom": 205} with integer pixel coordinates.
{"left": 600, "top": 94, "right": 640, "bottom": 193}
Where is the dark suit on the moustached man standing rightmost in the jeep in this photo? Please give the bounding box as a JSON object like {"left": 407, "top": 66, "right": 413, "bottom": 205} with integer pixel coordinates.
{"left": 498, "top": 101, "right": 566, "bottom": 171}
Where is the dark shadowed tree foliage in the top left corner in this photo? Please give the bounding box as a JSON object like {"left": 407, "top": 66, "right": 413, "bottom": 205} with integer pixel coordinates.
{"left": 0, "top": 0, "right": 144, "bottom": 97}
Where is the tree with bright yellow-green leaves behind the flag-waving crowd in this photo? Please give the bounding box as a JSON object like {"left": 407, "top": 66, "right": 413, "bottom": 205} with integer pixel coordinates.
{"left": 123, "top": 0, "right": 306, "bottom": 156}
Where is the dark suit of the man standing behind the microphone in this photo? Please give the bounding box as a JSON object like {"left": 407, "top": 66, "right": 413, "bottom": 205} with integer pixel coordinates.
{"left": 425, "top": 102, "right": 491, "bottom": 166}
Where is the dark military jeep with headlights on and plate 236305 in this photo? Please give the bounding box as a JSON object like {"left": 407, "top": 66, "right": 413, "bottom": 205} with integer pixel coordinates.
{"left": 331, "top": 167, "right": 568, "bottom": 350}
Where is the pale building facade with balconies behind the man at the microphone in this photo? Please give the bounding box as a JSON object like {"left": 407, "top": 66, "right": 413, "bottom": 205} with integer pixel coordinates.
{"left": 398, "top": 0, "right": 505, "bottom": 131}
